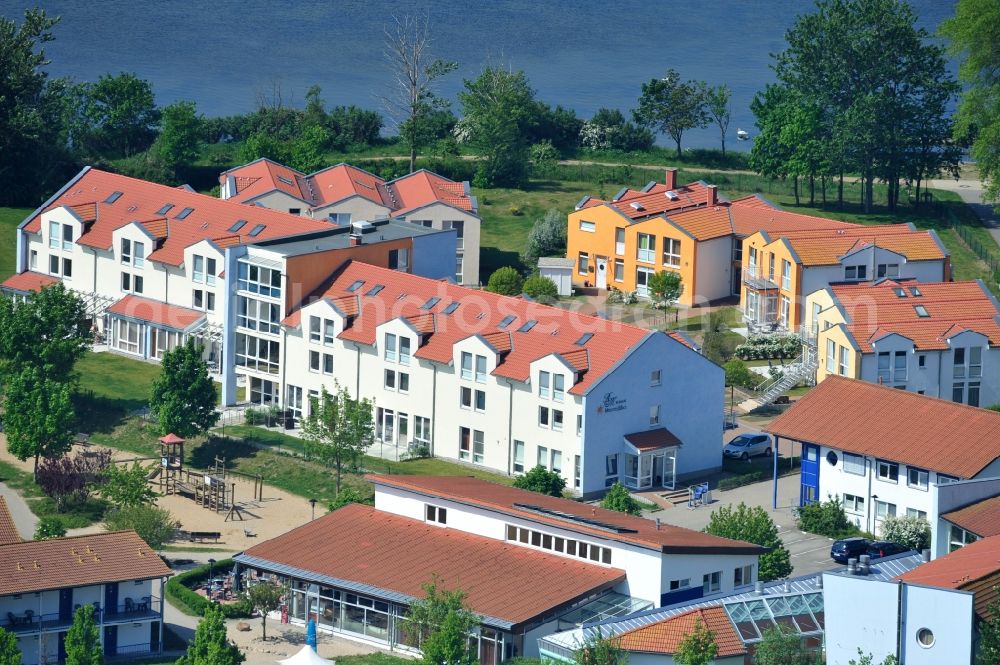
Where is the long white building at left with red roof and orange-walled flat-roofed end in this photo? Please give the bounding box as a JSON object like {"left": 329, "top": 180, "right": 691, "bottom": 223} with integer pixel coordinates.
{"left": 0, "top": 167, "right": 455, "bottom": 384}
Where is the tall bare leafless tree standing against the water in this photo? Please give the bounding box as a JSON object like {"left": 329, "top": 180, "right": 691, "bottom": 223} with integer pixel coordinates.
{"left": 382, "top": 16, "right": 458, "bottom": 172}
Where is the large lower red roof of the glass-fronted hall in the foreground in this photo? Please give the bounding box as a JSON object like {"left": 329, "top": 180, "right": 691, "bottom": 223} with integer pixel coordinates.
{"left": 244, "top": 504, "right": 625, "bottom": 624}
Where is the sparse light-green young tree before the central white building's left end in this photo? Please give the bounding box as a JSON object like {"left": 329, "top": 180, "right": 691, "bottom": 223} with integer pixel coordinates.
{"left": 302, "top": 383, "right": 375, "bottom": 494}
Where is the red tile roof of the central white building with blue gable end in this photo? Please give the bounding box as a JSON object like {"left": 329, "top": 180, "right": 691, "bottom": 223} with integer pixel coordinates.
{"left": 294, "top": 262, "right": 662, "bottom": 395}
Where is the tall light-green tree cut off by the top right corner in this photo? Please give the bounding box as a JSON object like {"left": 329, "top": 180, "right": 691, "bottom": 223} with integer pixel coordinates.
{"left": 941, "top": 0, "right": 1000, "bottom": 203}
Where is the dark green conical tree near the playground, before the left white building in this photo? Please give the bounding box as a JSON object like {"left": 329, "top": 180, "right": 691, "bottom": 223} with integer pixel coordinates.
{"left": 149, "top": 339, "right": 219, "bottom": 439}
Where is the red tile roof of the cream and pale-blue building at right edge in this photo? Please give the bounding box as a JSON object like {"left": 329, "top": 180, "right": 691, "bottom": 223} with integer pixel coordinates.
{"left": 830, "top": 280, "right": 1000, "bottom": 353}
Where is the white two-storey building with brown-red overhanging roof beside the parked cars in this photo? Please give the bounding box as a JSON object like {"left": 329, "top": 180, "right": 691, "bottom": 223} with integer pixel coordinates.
{"left": 764, "top": 376, "right": 1000, "bottom": 533}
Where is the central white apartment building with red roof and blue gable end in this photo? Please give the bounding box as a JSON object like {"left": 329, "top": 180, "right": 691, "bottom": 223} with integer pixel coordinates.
{"left": 274, "top": 262, "right": 724, "bottom": 495}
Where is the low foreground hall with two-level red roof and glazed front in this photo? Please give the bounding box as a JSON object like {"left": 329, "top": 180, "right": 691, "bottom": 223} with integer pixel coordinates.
{"left": 234, "top": 475, "right": 763, "bottom": 665}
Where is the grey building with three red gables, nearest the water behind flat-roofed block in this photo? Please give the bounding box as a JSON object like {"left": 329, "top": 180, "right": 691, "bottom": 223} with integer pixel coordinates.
{"left": 219, "top": 158, "right": 480, "bottom": 285}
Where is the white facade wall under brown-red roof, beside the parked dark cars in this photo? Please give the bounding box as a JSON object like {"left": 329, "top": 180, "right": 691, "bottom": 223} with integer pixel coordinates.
{"left": 819, "top": 446, "right": 951, "bottom": 534}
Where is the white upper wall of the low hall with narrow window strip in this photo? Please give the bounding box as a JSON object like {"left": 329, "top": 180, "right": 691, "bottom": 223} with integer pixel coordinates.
{"left": 375, "top": 486, "right": 757, "bottom": 608}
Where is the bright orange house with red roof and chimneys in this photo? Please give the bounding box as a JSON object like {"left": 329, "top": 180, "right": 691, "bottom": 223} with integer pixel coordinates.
{"left": 566, "top": 169, "right": 855, "bottom": 306}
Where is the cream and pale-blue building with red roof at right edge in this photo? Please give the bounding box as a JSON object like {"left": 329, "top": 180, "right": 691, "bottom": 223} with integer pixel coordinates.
{"left": 806, "top": 279, "right": 1000, "bottom": 406}
